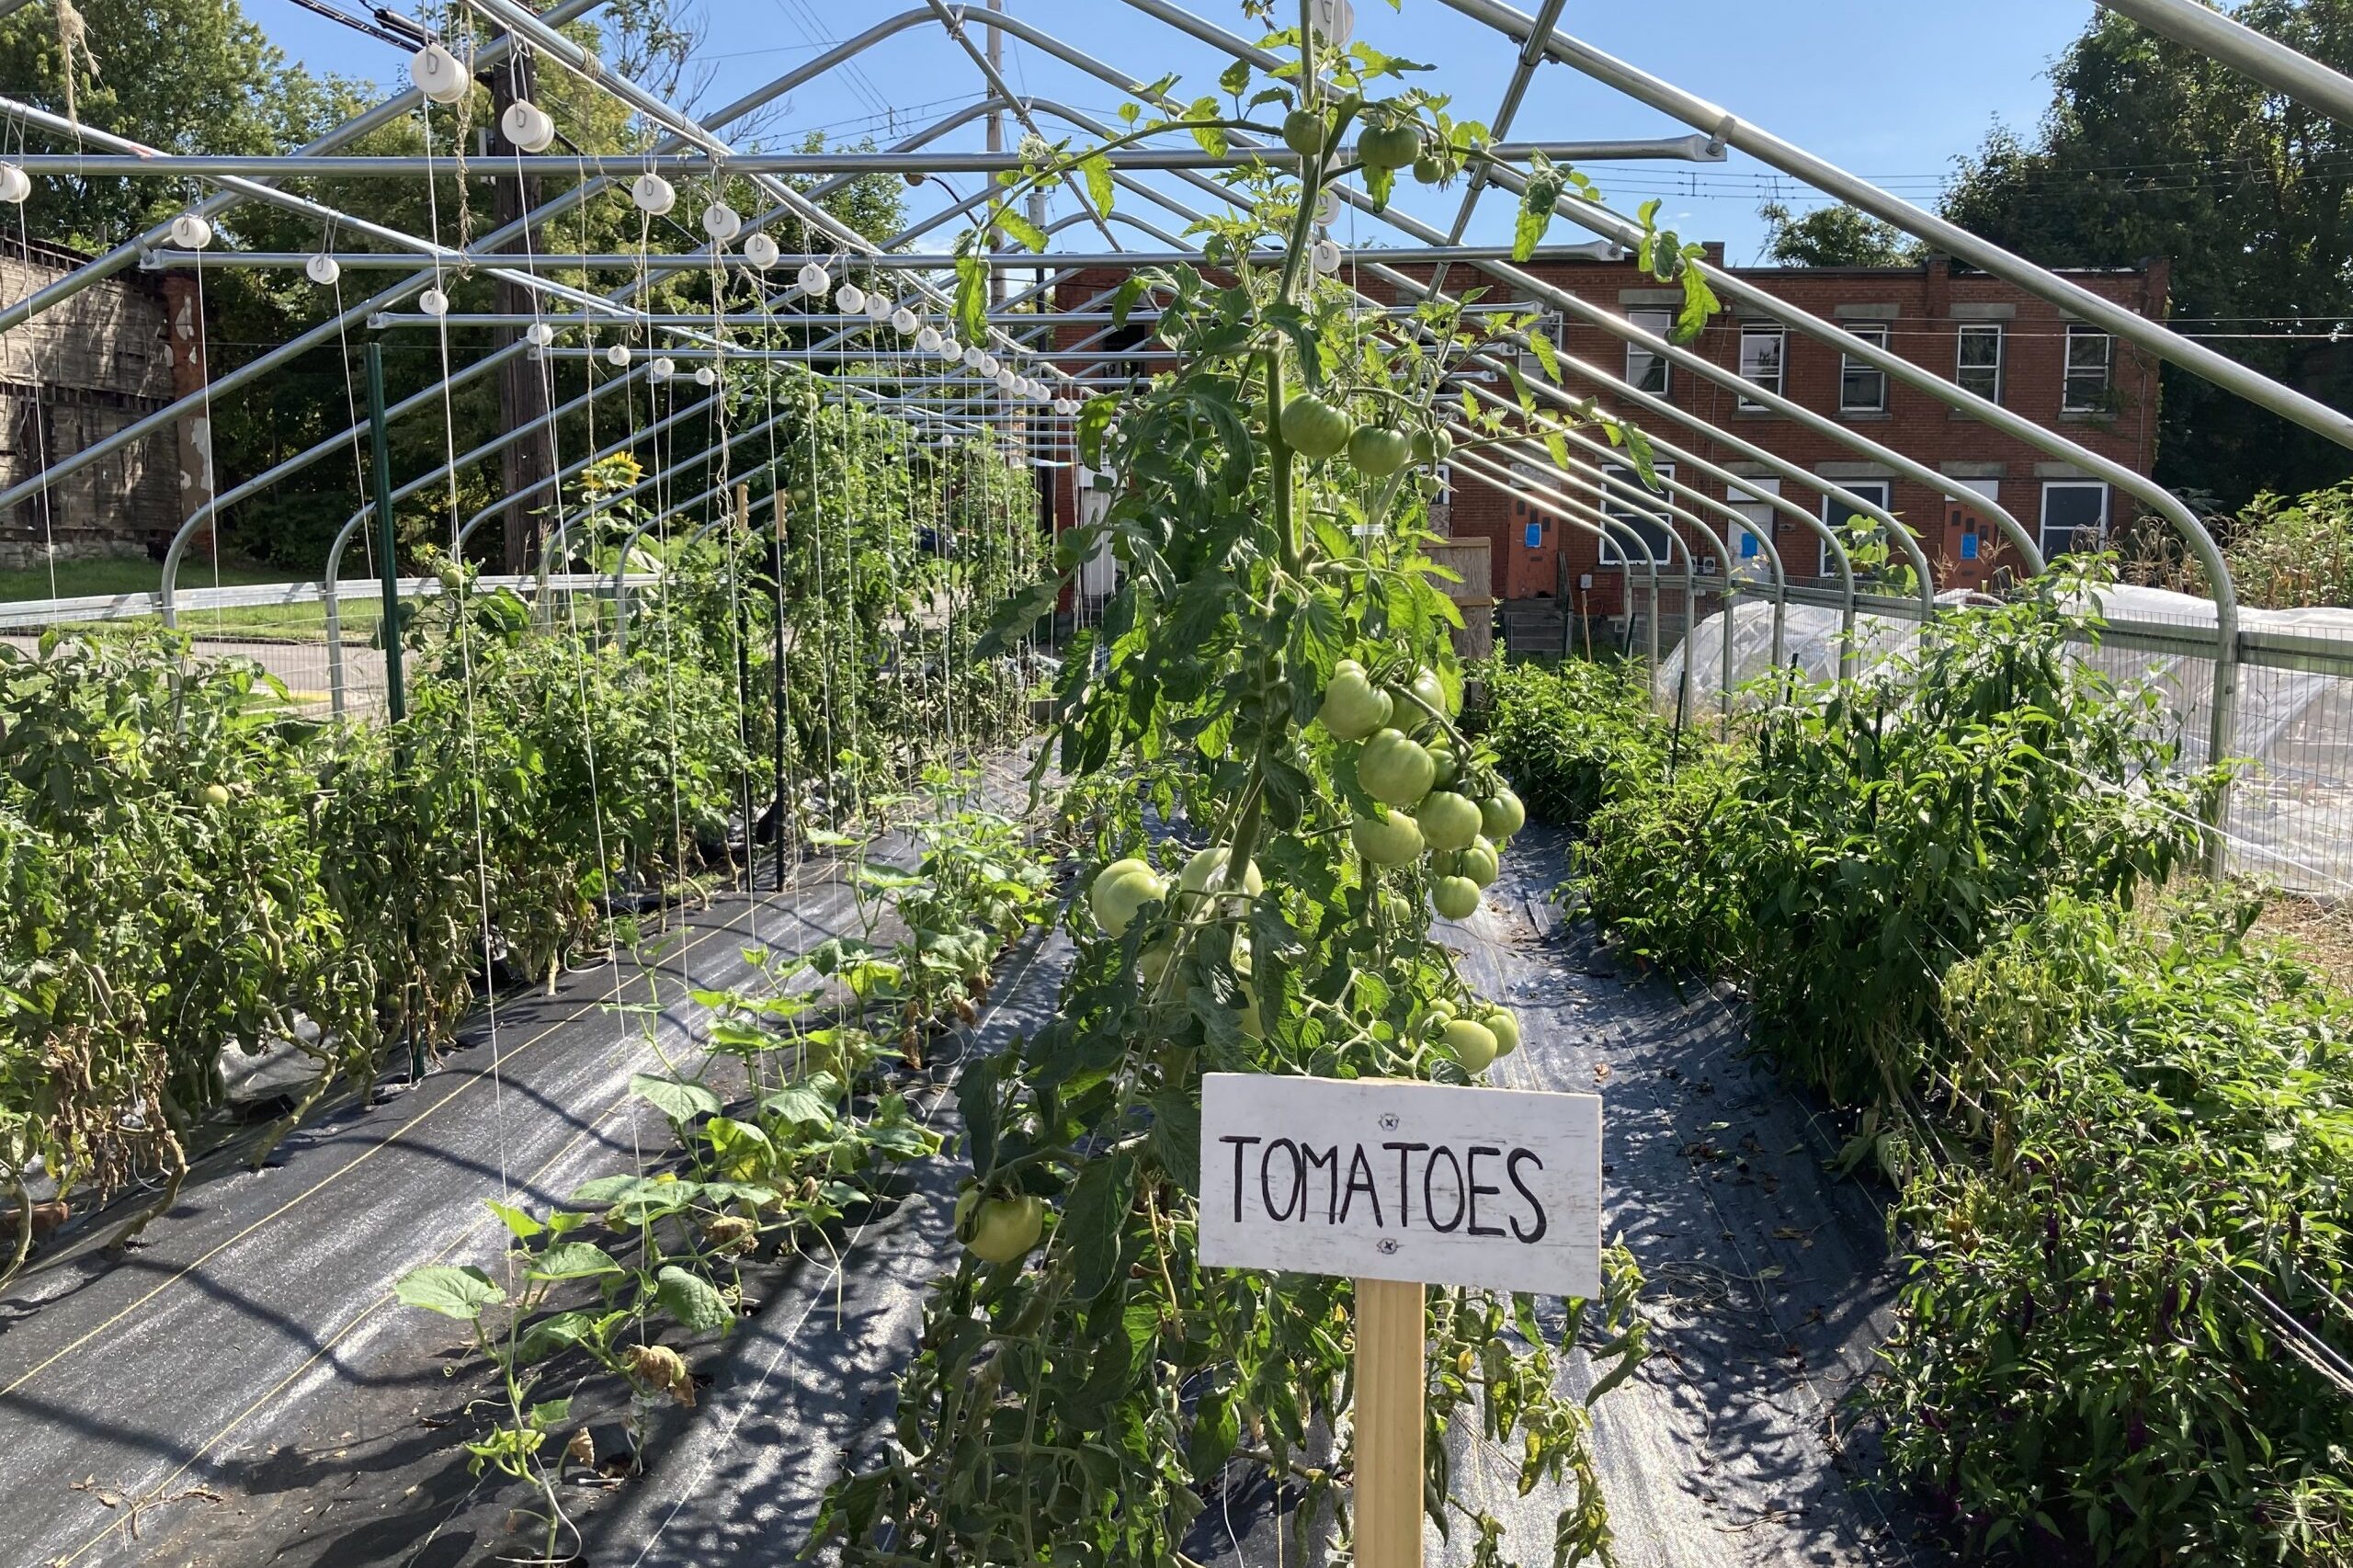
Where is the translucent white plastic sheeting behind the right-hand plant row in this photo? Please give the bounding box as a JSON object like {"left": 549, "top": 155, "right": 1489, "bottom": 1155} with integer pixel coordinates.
{"left": 1654, "top": 584, "right": 2353, "bottom": 900}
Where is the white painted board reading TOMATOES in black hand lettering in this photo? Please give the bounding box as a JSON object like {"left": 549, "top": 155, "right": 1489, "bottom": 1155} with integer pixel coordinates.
{"left": 1200, "top": 1074, "right": 1602, "bottom": 1297}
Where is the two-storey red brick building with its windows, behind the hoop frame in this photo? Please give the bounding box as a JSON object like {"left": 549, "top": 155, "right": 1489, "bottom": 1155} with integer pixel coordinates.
{"left": 1056, "top": 244, "right": 2167, "bottom": 619}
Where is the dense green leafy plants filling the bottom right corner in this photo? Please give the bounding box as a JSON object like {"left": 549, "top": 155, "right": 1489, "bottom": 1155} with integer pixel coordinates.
{"left": 1875, "top": 894, "right": 2353, "bottom": 1565}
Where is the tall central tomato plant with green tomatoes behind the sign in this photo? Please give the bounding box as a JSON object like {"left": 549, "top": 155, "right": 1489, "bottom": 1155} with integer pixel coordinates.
{"left": 824, "top": 15, "right": 1643, "bottom": 1563}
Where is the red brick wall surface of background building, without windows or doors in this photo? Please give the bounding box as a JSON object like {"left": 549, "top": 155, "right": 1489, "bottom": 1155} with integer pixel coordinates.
{"left": 1056, "top": 247, "right": 2167, "bottom": 615}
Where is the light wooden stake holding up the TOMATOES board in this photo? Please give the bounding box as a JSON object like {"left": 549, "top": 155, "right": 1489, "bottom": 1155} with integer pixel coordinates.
{"left": 1356, "top": 1278, "right": 1424, "bottom": 1568}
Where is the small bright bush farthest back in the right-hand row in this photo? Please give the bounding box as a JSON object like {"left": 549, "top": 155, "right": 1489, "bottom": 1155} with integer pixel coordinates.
{"left": 1466, "top": 659, "right": 1671, "bottom": 829}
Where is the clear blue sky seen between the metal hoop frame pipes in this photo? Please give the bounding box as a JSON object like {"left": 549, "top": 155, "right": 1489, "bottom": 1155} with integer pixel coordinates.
{"left": 243, "top": 0, "right": 2092, "bottom": 261}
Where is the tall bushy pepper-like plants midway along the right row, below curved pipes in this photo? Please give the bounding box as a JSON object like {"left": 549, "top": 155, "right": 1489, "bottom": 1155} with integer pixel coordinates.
{"left": 1581, "top": 572, "right": 2195, "bottom": 1104}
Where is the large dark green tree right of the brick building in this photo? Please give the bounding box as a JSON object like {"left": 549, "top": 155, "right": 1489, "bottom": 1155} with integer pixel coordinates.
{"left": 1944, "top": 0, "right": 2353, "bottom": 506}
